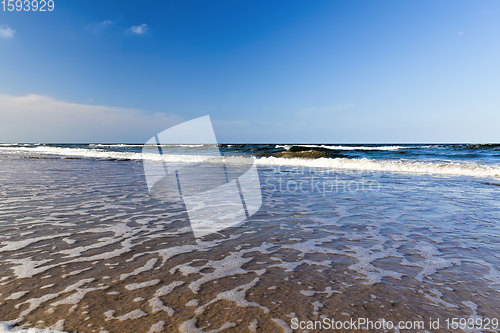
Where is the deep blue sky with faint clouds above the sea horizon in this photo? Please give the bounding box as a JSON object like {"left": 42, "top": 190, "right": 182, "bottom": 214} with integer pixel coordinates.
{"left": 0, "top": 0, "right": 500, "bottom": 143}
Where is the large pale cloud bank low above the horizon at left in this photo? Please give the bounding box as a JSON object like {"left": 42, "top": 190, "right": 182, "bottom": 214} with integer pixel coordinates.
{"left": 0, "top": 95, "right": 183, "bottom": 142}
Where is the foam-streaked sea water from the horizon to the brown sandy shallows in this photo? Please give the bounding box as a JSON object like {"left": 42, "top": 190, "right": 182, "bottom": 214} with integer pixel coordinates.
{"left": 0, "top": 144, "right": 500, "bottom": 332}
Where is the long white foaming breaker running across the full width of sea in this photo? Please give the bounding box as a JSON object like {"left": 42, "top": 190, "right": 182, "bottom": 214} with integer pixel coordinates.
{"left": 0, "top": 147, "right": 500, "bottom": 178}
